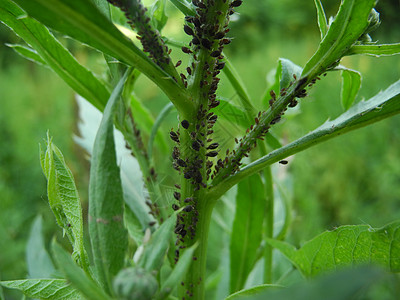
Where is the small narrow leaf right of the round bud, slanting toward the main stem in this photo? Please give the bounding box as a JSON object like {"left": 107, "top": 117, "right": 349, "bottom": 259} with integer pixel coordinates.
{"left": 157, "top": 243, "right": 198, "bottom": 299}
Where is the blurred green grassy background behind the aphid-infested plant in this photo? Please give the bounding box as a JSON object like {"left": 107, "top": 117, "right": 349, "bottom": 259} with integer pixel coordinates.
{"left": 0, "top": 0, "right": 400, "bottom": 298}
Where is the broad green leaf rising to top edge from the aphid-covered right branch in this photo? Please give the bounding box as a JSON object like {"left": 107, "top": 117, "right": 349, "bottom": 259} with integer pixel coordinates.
{"left": 302, "top": 0, "right": 375, "bottom": 79}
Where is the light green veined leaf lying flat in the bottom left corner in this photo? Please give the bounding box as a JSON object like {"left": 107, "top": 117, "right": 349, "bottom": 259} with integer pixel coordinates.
{"left": 0, "top": 279, "right": 85, "bottom": 300}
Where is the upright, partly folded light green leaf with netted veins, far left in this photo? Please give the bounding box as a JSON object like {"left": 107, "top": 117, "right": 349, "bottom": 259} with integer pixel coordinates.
{"left": 39, "top": 134, "right": 89, "bottom": 272}
